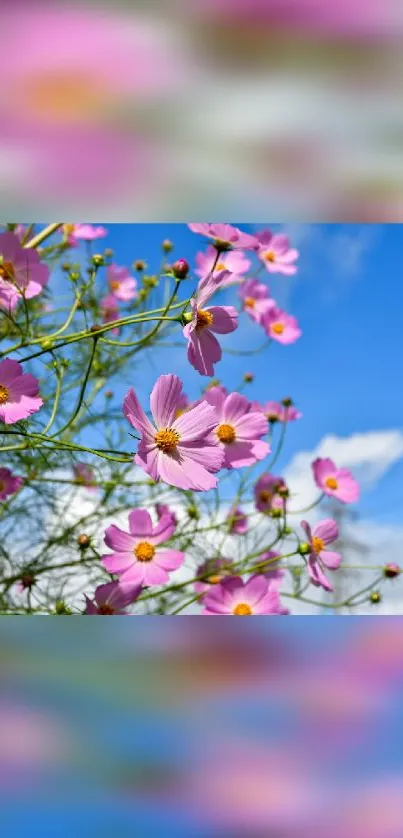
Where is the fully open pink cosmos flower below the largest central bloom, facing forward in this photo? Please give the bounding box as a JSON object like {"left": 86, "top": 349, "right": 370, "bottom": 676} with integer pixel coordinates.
{"left": 102, "top": 509, "right": 185, "bottom": 586}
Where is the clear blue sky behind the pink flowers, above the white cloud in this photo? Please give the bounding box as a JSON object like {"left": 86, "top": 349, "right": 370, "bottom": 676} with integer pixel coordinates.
{"left": 73, "top": 224, "right": 403, "bottom": 523}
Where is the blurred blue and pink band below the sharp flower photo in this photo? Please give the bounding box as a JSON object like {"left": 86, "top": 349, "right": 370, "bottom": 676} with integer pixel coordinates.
{"left": 0, "top": 617, "right": 403, "bottom": 838}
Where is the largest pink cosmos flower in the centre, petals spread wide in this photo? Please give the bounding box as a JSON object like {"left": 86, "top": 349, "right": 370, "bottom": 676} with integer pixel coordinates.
{"left": 123, "top": 375, "right": 224, "bottom": 492}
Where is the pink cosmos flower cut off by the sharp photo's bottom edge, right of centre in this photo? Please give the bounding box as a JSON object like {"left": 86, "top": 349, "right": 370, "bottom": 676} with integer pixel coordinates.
{"left": 203, "top": 575, "right": 284, "bottom": 617}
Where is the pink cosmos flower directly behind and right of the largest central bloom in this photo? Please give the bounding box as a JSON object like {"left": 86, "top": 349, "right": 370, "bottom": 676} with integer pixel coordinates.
{"left": 204, "top": 387, "right": 270, "bottom": 468}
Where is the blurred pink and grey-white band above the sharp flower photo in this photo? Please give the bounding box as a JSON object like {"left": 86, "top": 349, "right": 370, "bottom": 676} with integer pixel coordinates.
{"left": 0, "top": 0, "right": 403, "bottom": 221}
